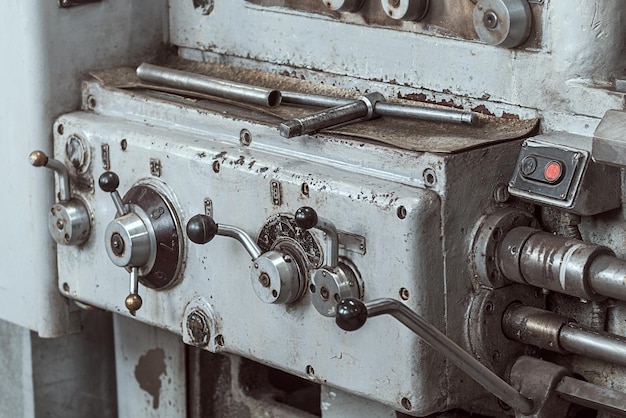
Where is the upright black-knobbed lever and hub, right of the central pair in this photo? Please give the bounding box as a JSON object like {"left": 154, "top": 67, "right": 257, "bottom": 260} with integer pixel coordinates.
{"left": 295, "top": 206, "right": 362, "bottom": 317}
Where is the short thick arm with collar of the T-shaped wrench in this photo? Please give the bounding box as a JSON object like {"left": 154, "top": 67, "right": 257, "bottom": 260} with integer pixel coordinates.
{"left": 279, "top": 93, "right": 385, "bottom": 138}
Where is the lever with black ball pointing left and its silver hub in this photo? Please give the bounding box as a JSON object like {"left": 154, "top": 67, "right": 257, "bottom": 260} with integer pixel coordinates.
{"left": 187, "top": 214, "right": 306, "bottom": 304}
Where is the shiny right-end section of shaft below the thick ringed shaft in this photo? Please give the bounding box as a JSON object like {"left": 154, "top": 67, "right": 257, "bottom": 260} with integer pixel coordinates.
{"left": 559, "top": 323, "right": 626, "bottom": 366}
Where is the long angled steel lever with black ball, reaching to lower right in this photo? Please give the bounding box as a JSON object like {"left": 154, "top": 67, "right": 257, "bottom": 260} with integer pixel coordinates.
{"left": 335, "top": 299, "right": 534, "bottom": 414}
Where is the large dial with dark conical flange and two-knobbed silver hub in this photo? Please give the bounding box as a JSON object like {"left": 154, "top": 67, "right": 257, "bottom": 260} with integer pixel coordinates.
{"left": 98, "top": 171, "right": 183, "bottom": 315}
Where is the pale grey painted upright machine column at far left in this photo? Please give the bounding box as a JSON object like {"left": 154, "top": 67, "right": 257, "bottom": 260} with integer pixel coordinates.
{"left": 0, "top": 0, "right": 167, "bottom": 337}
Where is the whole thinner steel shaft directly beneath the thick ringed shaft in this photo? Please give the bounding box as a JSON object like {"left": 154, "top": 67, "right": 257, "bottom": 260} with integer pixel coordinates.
{"left": 502, "top": 304, "right": 626, "bottom": 366}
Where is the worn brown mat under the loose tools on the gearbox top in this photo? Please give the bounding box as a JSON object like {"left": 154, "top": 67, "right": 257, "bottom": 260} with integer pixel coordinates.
{"left": 92, "top": 59, "right": 538, "bottom": 153}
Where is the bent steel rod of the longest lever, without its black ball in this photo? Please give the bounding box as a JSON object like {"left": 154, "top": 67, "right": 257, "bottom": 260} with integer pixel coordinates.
{"left": 365, "top": 299, "right": 533, "bottom": 414}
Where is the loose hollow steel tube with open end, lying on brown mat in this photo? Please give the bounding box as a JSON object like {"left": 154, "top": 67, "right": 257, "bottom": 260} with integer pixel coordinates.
{"left": 137, "top": 64, "right": 282, "bottom": 107}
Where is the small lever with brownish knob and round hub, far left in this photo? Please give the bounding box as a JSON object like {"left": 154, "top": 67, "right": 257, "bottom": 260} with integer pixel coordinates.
{"left": 30, "top": 151, "right": 91, "bottom": 245}
